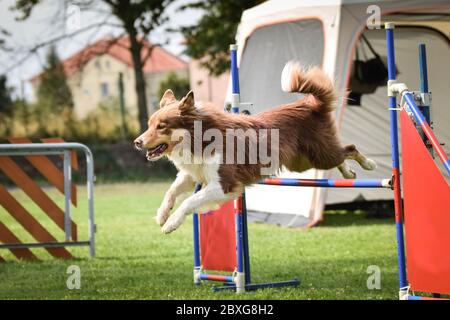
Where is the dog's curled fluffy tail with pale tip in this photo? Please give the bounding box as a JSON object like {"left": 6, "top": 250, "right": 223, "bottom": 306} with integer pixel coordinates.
{"left": 281, "top": 61, "right": 336, "bottom": 113}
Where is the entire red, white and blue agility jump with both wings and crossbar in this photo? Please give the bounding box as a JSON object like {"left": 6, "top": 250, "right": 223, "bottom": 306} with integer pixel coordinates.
{"left": 193, "top": 23, "right": 450, "bottom": 300}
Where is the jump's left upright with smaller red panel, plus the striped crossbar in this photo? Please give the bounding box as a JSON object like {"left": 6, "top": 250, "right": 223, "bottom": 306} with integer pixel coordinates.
{"left": 193, "top": 45, "right": 391, "bottom": 293}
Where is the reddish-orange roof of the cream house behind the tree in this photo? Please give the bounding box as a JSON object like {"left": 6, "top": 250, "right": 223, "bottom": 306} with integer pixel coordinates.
{"left": 31, "top": 36, "right": 188, "bottom": 81}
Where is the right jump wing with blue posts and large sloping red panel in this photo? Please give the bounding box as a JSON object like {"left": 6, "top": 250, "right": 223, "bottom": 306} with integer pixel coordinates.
{"left": 385, "top": 23, "right": 450, "bottom": 300}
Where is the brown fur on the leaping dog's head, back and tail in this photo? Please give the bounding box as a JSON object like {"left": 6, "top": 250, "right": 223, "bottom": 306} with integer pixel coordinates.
{"left": 135, "top": 68, "right": 374, "bottom": 193}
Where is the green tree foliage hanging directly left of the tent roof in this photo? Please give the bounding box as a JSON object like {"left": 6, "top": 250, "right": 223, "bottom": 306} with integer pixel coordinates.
{"left": 177, "top": 0, "right": 264, "bottom": 75}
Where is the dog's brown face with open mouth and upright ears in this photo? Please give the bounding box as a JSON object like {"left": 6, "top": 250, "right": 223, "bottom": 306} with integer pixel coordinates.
{"left": 134, "top": 89, "right": 195, "bottom": 161}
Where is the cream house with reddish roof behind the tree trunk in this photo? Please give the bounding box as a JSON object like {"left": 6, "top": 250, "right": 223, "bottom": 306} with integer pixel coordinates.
{"left": 31, "top": 37, "right": 188, "bottom": 118}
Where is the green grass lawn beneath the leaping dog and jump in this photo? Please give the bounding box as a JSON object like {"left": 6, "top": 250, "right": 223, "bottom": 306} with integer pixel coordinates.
{"left": 0, "top": 182, "right": 398, "bottom": 299}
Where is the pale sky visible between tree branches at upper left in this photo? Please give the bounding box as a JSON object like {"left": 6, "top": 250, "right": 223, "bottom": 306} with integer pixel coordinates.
{"left": 0, "top": 0, "right": 201, "bottom": 100}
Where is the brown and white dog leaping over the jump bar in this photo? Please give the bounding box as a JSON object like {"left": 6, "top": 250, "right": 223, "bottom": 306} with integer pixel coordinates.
{"left": 134, "top": 62, "right": 376, "bottom": 233}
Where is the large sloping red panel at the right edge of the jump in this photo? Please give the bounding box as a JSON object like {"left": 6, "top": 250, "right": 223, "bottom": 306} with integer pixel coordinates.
{"left": 400, "top": 111, "right": 450, "bottom": 294}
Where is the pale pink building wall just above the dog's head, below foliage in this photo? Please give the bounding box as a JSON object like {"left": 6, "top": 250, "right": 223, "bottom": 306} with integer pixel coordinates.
{"left": 189, "top": 60, "right": 229, "bottom": 108}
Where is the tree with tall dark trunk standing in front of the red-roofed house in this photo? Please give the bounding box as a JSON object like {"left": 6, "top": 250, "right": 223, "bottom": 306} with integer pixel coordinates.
{"left": 13, "top": 0, "right": 174, "bottom": 131}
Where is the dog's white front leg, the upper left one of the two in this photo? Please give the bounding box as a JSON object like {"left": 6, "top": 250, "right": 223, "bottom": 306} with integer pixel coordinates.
{"left": 156, "top": 171, "right": 195, "bottom": 226}
